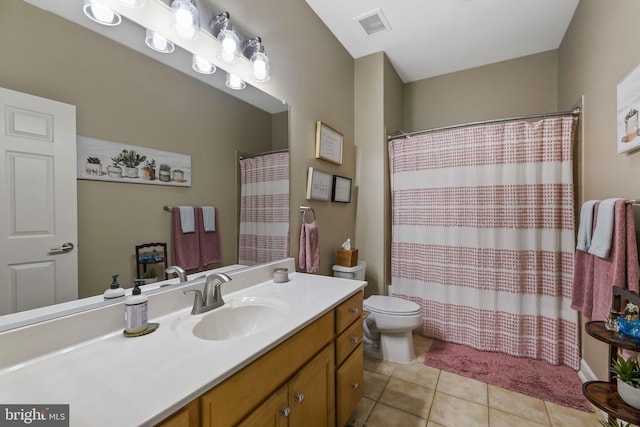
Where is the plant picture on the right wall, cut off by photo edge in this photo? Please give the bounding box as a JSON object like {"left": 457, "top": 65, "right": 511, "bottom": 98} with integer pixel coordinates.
{"left": 616, "top": 67, "right": 640, "bottom": 154}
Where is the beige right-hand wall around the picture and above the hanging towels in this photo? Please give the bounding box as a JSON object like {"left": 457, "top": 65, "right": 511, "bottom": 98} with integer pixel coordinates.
{"left": 558, "top": 0, "right": 640, "bottom": 379}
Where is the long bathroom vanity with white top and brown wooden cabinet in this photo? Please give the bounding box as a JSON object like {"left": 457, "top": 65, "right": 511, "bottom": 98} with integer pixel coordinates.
{"left": 0, "top": 259, "right": 366, "bottom": 427}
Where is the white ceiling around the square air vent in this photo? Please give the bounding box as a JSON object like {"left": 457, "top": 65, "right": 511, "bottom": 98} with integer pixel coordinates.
{"left": 306, "top": 0, "right": 579, "bottom": 83}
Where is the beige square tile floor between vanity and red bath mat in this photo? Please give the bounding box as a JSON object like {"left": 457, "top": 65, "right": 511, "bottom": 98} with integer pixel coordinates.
{"left": 352, "top": 335, "right": 616, "bottom": 427}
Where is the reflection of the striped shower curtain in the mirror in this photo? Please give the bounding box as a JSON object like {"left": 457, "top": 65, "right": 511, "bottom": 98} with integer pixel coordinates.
{"left": 238, "top": 152, "right": 289, "bottom": 265}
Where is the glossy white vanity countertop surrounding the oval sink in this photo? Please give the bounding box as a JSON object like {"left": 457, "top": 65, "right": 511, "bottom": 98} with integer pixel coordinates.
{"left": 0, "top": 266, "right": 366, "bottom": 427}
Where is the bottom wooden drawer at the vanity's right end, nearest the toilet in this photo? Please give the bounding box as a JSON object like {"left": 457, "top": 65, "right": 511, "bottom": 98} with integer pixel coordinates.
{"left": 336, "top": 344, "right": 364, "bottom": 426}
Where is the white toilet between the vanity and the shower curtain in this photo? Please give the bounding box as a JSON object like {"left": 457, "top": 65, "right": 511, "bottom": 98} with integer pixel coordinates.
{"left": 333, "top": 261, "right": 422, "bottom": 363}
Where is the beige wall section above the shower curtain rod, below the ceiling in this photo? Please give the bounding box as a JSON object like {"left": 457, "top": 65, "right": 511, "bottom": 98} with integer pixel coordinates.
{"left": 403, "top": 50, "right": 558, "bottom": 132}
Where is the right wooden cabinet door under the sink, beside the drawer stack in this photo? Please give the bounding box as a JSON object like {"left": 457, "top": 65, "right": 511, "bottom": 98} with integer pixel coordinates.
{"left": 289, "top": 345, "right": 335, "bottom": 427}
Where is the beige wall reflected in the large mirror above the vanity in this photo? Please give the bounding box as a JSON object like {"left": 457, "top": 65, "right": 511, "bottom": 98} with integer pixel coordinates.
{"left": 0, "top": 0, "right": 289, "bottom": 322}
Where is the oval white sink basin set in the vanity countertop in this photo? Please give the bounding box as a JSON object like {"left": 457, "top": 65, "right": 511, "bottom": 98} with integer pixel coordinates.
{"left": 172, "top": 297, "right": 289, "bottom": 341}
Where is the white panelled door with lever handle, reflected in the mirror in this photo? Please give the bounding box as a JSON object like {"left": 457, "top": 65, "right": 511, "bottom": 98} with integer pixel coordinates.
{"left": 0, "top": 88, "right": 78, "bottom": 314}
